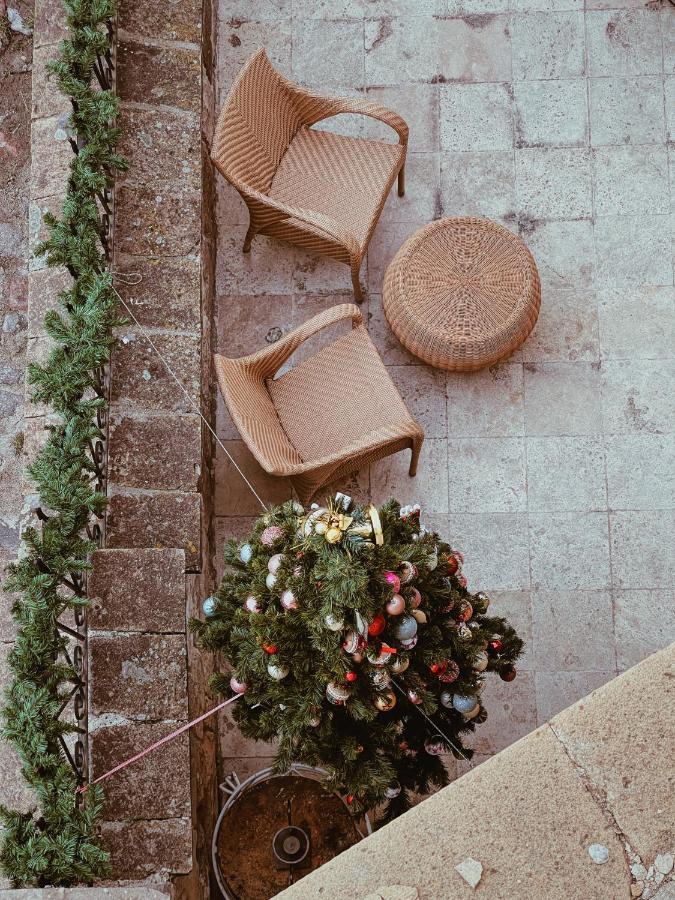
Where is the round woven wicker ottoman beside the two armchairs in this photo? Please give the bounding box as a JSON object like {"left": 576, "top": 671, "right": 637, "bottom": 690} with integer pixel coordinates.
{"left": 382, "top": 218, "right": 541, "bottom": 372}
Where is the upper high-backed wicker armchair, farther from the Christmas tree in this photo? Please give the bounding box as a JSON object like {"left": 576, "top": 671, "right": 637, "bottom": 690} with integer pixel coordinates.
{"left": 211, "top": 49, "right": 408, "bottom": 302}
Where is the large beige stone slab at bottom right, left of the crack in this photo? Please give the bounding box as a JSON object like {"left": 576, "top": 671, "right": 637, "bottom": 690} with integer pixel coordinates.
{"left": 278, "top": 724, "right": 627, "bottom": 900}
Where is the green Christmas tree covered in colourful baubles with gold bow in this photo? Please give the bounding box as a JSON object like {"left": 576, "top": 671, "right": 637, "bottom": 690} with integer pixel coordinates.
{"left": 192, "top": 494, "right": 522, "bottom": 820}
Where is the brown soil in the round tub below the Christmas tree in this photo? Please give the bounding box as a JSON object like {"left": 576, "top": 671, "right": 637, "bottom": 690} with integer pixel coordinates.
{"left": 218, "top": 775, "right": 361, "bottom": 900}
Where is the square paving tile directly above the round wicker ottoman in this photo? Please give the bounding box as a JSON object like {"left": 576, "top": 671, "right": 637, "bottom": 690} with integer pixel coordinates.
{"left": 440, "top": 151, "right": 515, "bottom": 219}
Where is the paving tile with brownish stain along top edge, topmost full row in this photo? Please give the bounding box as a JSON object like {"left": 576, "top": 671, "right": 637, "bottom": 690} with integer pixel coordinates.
{"left": 436, "top": 12, "right": 511, "bottom": 82}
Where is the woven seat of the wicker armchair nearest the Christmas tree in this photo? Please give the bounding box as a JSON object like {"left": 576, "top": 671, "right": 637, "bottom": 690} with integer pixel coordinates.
{"left": 267, "top": 325, "right": 418, "bottom": 462}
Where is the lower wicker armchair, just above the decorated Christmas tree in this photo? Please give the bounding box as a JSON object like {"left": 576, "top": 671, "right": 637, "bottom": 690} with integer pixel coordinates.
{"left": 215, "top": 303, "right": 424, "bottom": 503}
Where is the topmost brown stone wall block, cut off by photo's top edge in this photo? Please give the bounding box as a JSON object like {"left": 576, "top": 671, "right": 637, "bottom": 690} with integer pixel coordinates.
{"left": 117, "top": 0, "right": 202, "bottom": 44}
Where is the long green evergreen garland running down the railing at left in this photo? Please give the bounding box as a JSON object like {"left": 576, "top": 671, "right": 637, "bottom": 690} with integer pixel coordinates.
{"left": 0, "top": 0, "right": 125, "bottom": 887}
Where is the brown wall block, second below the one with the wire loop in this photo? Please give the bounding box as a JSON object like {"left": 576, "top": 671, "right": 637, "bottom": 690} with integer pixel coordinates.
{"left": 108, "top": 415, "right": 201, "bottom": 491}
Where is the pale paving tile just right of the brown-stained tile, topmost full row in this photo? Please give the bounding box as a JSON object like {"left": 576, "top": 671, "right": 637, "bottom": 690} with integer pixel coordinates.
{"left": 511, "top": 12, "right": 584, "bottom": 81}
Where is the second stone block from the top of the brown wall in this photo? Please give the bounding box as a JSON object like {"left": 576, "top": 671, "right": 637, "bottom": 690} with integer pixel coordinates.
{"left": 117, "top": 42, "right": 201, "bottom": 113}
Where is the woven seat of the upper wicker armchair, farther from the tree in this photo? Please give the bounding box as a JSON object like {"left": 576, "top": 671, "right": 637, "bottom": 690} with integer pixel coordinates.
{"left": 269, "top": 126, "right": 405, "bottom": 250}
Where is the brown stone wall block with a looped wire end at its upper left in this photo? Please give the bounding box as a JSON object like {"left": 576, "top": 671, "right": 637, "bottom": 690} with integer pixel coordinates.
{"left": 115, "top": 253, "right": 201, "bottom": 331}
